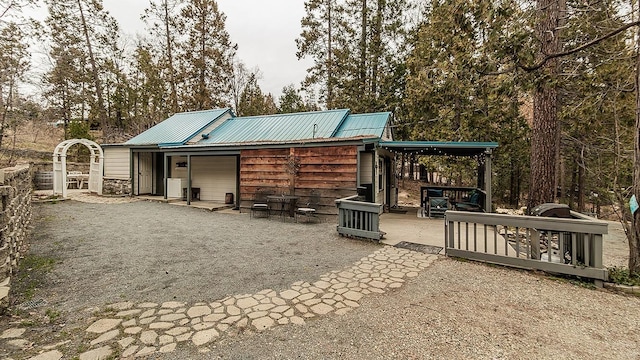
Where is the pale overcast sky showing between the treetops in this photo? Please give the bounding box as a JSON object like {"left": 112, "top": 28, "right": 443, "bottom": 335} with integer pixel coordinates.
{"left": 28, "top": 0, "right": 311, "bottom": 100}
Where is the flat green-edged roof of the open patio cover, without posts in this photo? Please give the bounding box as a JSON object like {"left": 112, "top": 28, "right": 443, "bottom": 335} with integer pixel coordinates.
{"left": 378, "top": 141, "right": 498, "bottom": 156}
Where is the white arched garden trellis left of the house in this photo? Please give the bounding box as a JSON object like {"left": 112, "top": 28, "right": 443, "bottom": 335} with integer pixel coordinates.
{"left": 53, "top": 139, "right": 104, "bottom": 198}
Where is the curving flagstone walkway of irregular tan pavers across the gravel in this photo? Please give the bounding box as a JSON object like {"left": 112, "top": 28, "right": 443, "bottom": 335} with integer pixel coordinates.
{"left": 5, "top": 246, "right": 437, "bottom": 360}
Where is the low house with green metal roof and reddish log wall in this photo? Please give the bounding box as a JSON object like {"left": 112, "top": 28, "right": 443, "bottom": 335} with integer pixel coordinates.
{"left": 103, "top": 109, "right": 497, "bottom": 214}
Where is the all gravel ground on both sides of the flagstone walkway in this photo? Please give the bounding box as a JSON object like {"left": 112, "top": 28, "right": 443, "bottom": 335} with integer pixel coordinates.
{"left": 6, "top": 201, "right": 640, "bottom": 359}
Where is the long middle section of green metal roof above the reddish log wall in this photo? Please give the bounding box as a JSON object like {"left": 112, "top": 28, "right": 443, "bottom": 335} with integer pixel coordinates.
{"left": 198, "top": 109, "right": 349, "bottom": 144}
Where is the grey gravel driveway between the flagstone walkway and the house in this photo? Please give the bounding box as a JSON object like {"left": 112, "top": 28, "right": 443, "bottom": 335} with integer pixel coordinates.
{"left": 26, "top": 201, "right": 380, "bottom": 320}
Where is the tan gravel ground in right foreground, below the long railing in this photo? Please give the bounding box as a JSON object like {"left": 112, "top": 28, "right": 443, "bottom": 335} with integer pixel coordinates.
{"left": 199, "top": 258, "right": 640, "bottom": 359}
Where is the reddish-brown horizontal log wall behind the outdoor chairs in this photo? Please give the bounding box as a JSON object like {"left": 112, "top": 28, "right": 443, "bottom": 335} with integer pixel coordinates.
{"left": 240, "top": 145, "right": 358, "bottom": 215}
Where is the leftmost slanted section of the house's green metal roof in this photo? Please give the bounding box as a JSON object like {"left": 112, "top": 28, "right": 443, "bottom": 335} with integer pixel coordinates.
{"left": 125, "top": 109, "right": 231, "bottom": 146}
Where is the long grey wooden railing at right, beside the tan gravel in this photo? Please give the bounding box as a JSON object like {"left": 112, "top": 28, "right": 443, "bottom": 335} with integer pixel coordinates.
{"left": 445, "top": 211, "right": 608, "bottom": 281}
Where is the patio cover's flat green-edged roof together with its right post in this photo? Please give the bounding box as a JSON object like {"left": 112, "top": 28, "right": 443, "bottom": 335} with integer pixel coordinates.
{"left": 378, "top": 141, "right": 498, "bottom": 212}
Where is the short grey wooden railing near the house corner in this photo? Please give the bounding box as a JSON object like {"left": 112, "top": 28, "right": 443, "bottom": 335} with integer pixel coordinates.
{"left": 336, "top": 195, "right": 384, "bottom": 240}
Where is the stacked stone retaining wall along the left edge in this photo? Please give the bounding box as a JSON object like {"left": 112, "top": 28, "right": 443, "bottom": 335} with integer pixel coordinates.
{"left": 0, "top": 165, "right": 32, "bottom": 312}
